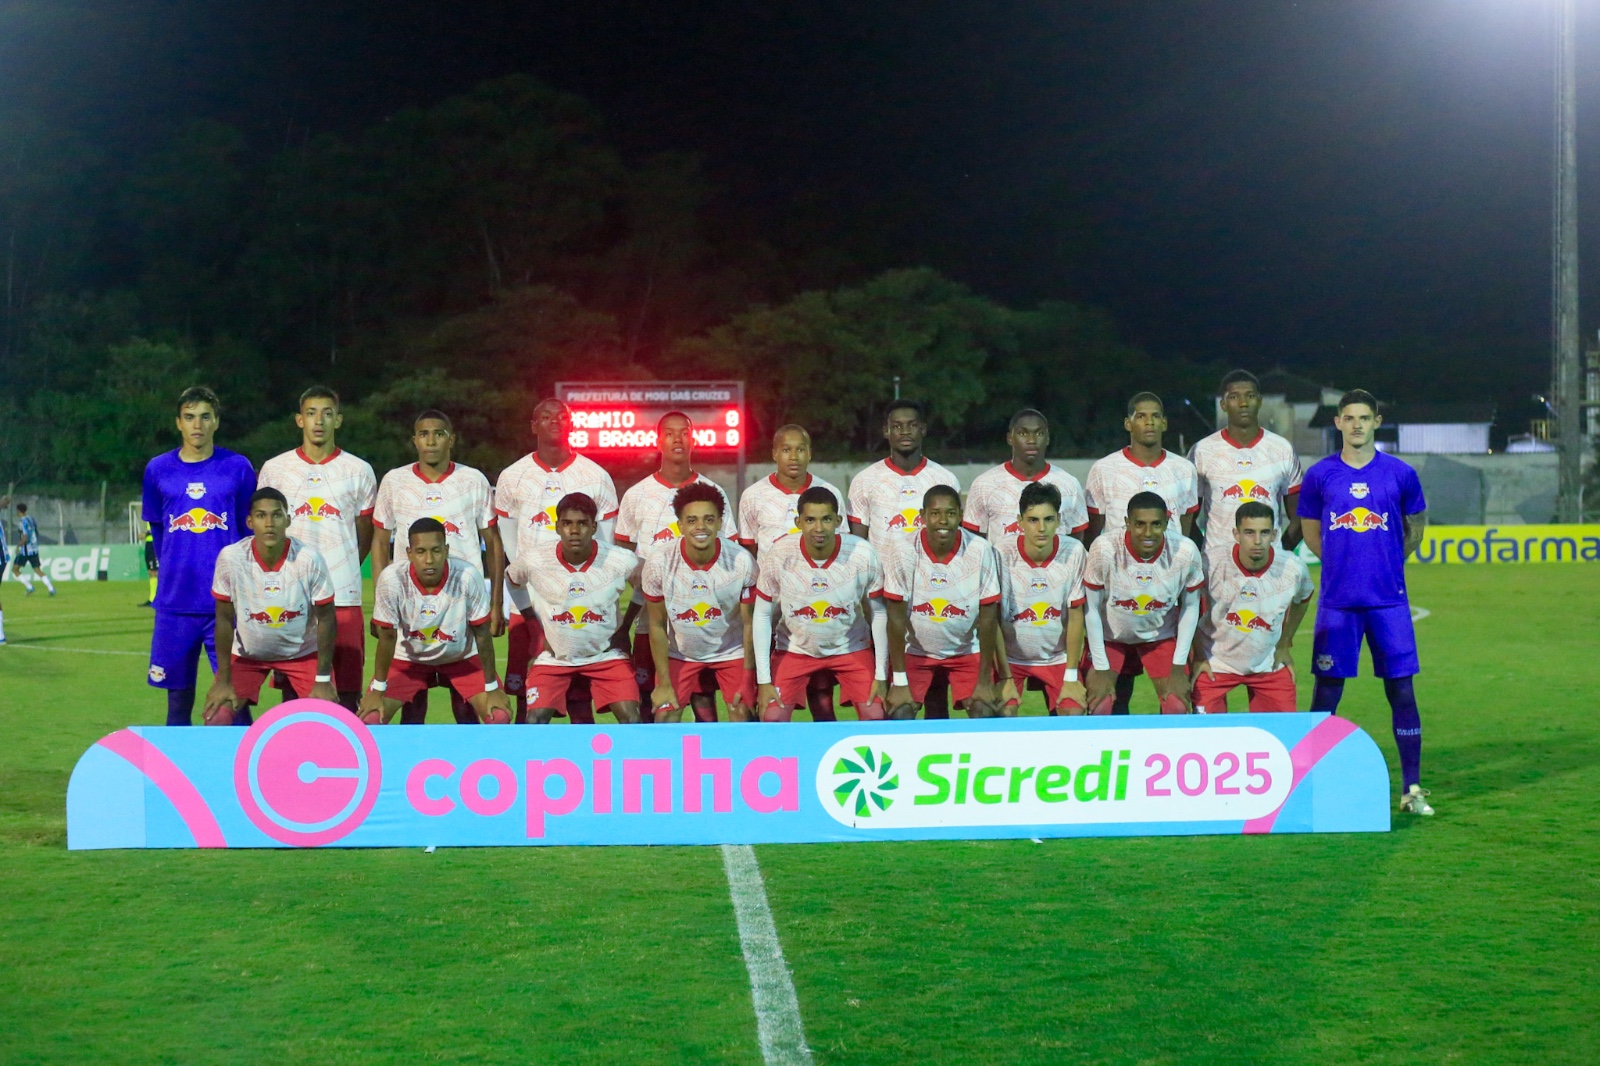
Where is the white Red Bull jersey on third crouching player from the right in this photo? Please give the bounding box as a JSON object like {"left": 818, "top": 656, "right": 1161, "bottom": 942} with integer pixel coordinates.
{"left": 995, "top": 535, "right": 1090, "bottom": 666}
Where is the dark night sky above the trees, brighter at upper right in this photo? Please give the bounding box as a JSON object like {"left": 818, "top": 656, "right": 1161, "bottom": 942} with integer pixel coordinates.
{"left": 0, "top": 0, "right": 1600, "bottom": 404}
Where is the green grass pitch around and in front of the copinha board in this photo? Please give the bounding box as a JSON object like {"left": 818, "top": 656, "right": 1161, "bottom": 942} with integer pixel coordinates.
{"left": 0, "top": 565, "right": 1600, "bottom": 1063}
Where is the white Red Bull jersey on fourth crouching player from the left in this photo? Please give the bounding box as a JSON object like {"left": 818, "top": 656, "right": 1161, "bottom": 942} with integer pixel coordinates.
{"left": 638, "top": 538, "right": 755, "bottom": 663}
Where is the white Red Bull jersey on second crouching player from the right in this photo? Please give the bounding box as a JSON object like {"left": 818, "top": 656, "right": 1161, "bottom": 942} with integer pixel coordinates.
{"left": 1083, "top": 531, "right": 1205, "bottom": 643}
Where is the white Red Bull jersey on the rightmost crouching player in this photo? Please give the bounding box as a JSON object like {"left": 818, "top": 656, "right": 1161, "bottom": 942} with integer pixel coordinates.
{"left": 1197, "top": 544, "right": 1317, "bottom": 674}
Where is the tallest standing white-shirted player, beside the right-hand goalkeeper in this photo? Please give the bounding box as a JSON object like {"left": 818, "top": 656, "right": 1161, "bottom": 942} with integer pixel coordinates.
{"left": 1189, "top": 370, "right": 1301, "bottom": 570}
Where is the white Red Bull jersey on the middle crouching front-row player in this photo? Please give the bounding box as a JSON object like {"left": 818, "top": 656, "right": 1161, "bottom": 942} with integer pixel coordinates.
{"left": 755, "top": 533, "right": 883, "bottom": 658}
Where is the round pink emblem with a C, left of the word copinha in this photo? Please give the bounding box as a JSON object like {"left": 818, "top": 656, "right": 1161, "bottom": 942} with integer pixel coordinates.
{"left": 234, "top": 699, "right": 382, "bottom": 848}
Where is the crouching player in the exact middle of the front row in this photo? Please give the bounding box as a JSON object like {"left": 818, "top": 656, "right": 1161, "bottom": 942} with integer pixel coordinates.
{"left": 752, "top": 485, "right": 890, "bottom": 722}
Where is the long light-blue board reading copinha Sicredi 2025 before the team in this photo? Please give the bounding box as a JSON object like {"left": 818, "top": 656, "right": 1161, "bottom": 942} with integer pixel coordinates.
{"left": 67, "top": 699, "right": 1389, "bottom": 850}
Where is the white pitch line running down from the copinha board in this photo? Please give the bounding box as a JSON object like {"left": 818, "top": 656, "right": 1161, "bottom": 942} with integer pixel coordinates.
{"left": 722, "top": 844, "right": 811, "bottom": 1066}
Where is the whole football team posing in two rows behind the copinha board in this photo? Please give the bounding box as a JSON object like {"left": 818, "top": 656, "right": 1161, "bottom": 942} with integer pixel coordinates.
{"left": 124, "top": 370, "right": 1434, "bottom": 815}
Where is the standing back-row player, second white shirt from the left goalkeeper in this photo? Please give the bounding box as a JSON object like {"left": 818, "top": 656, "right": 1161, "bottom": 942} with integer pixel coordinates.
{"left": 373, "top": 410, "right": 506, "bottom": 725}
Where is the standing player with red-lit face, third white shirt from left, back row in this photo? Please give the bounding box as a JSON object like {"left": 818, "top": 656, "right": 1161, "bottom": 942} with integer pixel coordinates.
{"left": 494, "top": 400, "right": 618, "bottom": 725}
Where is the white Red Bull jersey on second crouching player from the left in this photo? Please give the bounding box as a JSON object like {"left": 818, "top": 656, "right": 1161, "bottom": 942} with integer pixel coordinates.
{"left": 373, "top": 559, "right": 490, "bottom": 666}
